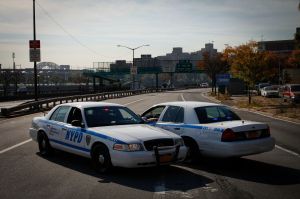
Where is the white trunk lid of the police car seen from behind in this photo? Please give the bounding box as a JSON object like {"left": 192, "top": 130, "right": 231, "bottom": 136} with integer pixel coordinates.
{"left": 204, "top": 120, "right": 268, "bottom": 132}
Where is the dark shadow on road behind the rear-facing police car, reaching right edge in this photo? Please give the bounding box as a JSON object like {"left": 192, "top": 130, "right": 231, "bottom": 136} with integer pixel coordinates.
{"left": 184, "top": 158, "right": 300, "bottom": 185}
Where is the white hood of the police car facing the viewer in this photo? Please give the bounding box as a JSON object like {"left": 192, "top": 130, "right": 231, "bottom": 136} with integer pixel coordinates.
{"left": 88, "top": 124, "right": 180, "bottom": 143}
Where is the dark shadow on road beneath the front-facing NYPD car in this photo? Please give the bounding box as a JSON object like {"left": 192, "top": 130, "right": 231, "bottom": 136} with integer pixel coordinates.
{"left": 37, "top": 151, "right": 213, "bottom": 192}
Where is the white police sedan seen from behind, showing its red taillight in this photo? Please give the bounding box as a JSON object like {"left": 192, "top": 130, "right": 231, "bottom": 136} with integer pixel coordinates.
{"left": 142, "top": 101, "right": 275, "bottom": 161}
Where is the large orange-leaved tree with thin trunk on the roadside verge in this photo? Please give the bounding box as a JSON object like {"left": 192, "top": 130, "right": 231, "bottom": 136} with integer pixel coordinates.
{"left": 224, "top": 41, "right": 278, "bottom": 104}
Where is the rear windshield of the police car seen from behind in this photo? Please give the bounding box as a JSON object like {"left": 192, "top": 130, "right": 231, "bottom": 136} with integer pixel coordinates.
{"left": 195, "top": 106, "right": 241, "bottom": 124}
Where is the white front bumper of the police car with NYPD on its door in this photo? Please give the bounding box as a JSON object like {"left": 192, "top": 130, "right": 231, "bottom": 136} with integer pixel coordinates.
{"left": 110, "top": 146, "right": 187, "bottom": 168}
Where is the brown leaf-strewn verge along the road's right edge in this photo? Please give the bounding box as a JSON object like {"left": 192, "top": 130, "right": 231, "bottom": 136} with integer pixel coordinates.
{"left": 209, "top": 93, "right": 300, "bottom": 123}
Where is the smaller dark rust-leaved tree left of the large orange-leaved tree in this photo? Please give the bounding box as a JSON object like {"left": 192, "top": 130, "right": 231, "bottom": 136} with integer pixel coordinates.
{"left": 199, "top": 52, "right": 229, "bottom": 93}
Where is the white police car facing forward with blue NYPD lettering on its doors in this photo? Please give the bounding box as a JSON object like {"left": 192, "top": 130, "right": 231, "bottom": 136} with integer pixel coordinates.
{"left": 29, "top": 102, "right": 187, "bottom": 172}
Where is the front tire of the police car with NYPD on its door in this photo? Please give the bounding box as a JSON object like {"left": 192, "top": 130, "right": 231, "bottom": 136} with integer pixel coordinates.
{"left": 91, "top": 144, "right": 112, "bottom": 173}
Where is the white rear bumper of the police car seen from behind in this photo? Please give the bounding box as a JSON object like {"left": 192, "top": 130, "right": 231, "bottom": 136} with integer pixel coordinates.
{"left": 201, "top": 137, "right": 275, "bottom": 158}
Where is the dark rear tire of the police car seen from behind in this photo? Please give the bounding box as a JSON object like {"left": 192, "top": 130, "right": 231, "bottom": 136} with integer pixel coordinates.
{"left": 183, "top": 137, "right": 200, "bottom": 163}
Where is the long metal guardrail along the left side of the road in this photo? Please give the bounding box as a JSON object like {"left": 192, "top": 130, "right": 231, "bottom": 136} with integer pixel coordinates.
{"left": 1, "top": 89, "right": 166, "bottom": 117}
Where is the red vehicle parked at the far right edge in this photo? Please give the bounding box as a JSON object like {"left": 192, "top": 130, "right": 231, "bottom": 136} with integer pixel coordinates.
{"left": 280, "top": 84, "right": 300, "bottom": 103}
